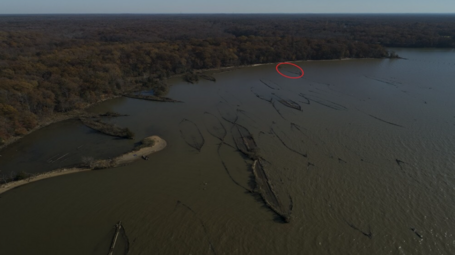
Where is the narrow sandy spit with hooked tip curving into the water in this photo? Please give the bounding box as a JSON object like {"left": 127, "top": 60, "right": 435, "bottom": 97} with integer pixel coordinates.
{"left": 0, "top": 136, "right": 167, "bottom": 195}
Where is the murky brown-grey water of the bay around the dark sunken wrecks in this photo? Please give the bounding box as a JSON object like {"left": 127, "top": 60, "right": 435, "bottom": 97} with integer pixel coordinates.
{"left": 0, "top": 49, "right": 455, "bottom": 254}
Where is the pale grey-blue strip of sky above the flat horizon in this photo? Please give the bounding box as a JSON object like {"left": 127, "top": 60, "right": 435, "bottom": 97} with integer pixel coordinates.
{"left": 0, "top": 0, "right": 455, "bottom": 14}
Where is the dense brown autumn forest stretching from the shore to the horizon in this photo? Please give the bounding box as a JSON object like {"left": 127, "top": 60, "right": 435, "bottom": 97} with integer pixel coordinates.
{"left": 0, "top": 15, "right": 455, "bottom": 145}
